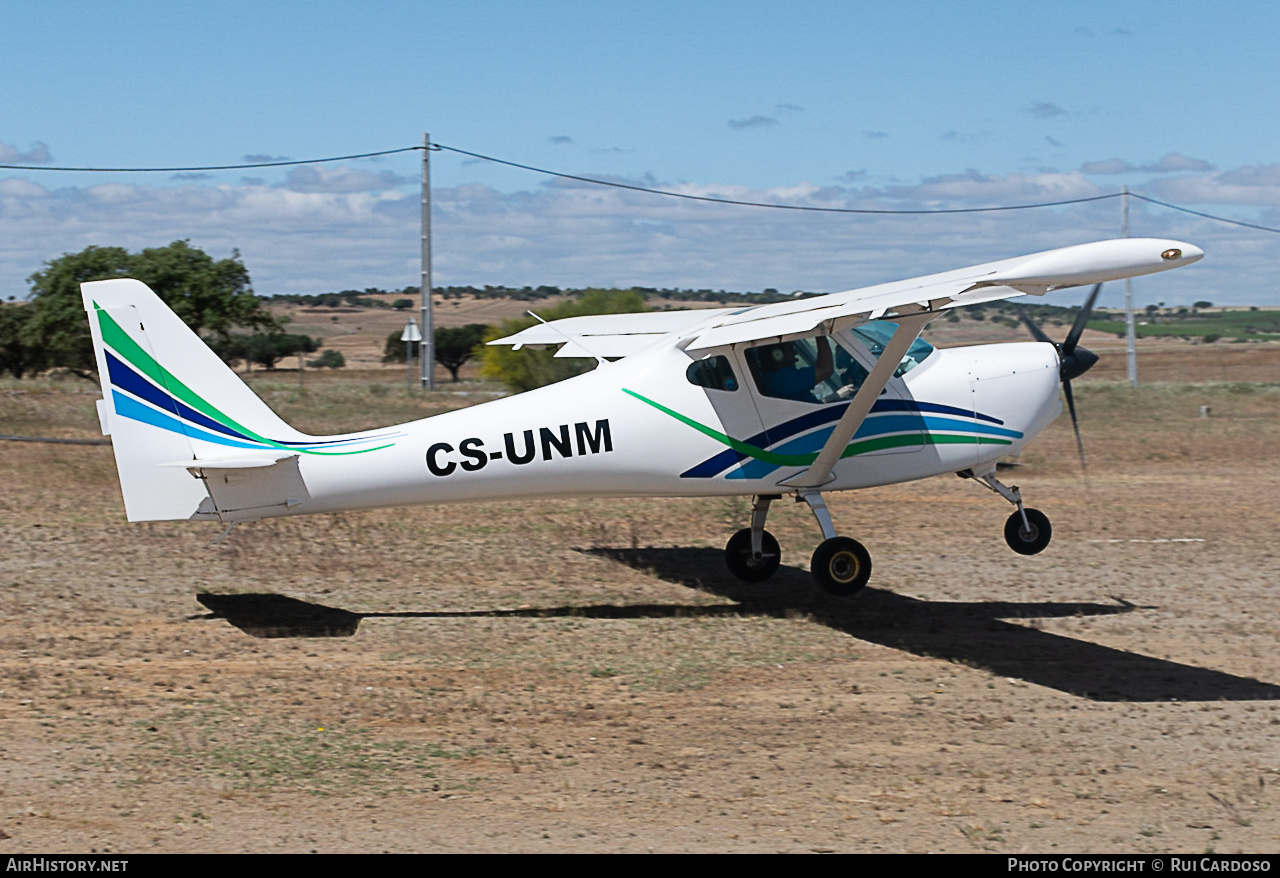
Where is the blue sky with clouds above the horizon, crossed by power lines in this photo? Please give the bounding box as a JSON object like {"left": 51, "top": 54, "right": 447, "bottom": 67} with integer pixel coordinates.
{"left": 0, "top": 0, "right": 1280, "bottom": 305}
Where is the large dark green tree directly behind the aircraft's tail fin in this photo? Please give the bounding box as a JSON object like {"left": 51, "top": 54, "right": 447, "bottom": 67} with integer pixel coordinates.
{"left": 28, "top": 241, "right": 279, "bottom": 378}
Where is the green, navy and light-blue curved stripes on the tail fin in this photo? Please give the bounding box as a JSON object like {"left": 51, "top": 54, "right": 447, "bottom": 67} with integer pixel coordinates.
{"left": 93, "top": 302, "right": 403, "bottom": 456}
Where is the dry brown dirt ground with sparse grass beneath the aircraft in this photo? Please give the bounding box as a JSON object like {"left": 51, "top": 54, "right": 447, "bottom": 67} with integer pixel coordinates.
{"left": 0, "top": 346, "right": 1280, "bottom": 852}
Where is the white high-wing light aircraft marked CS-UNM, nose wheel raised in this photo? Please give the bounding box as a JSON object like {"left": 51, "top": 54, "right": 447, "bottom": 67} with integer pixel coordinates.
{"left": 82, "top": 238, "right": 1203, "bottom": 595}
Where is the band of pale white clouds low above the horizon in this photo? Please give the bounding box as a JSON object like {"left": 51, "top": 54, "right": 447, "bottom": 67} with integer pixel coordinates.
{"left": 0, "top": 165, "right": 1280, "bottom": 302}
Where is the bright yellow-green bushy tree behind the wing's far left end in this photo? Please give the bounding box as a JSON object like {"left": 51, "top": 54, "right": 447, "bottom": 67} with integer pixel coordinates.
{"left": 481, "top": 289, "right": 646, "bottom": 393}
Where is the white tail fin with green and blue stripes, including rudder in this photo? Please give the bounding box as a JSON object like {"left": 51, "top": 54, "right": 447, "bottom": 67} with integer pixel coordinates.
{"left": 81, "top": 279, "right": 312, "bottom": 521}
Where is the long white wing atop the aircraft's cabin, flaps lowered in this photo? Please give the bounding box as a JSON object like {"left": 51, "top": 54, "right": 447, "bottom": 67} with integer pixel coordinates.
{"left": 489, "top": 238, "right": 1204, "bottom": 357}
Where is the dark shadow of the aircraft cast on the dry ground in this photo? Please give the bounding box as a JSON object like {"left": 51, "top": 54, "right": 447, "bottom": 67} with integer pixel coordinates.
{"left": 196, "top": 548, "right": 1280, "bottom": 701}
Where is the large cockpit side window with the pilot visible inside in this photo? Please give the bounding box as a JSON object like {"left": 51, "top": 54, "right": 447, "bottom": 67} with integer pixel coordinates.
{"left": 746, "top": 335, "right": 868, "bottom": 403}
